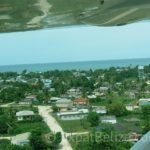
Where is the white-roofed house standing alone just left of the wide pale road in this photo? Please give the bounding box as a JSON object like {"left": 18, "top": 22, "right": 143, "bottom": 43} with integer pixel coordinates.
{"left": 16, "top": 110, "right": 34, "bottom": 121}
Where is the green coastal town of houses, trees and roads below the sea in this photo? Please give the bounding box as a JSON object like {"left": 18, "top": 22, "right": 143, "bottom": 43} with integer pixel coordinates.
{"left": 0, "top": 66, "right": 150, "bottom": 150}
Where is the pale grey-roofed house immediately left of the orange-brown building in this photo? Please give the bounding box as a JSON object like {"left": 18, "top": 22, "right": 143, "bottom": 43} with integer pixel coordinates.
{"left": 56, "top": 99, "right": 73, "bottom": 111}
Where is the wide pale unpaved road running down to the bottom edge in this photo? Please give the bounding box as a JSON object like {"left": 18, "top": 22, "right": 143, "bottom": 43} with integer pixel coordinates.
{"left": 38, "top": 106, "right": 72, "bottom": 150}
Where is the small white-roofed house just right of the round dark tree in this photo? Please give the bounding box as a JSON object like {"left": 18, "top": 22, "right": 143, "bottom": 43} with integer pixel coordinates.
{"left": 100, "top": 116, "right": 117, "bottom": 124}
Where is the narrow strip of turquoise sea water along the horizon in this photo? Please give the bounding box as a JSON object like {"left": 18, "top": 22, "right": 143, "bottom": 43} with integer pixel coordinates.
{"left": 0, "top": 58, "right": 150, "bottom": 72}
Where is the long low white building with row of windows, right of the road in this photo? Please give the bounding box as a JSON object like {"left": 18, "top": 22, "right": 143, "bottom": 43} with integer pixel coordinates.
{"left": 57, "top": 109, "right": 89, "bottom": 120}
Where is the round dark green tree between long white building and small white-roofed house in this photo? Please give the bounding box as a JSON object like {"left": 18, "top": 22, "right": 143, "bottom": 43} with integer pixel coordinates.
{"left": 87, "top": 112, "right": 99, "bottom": 127}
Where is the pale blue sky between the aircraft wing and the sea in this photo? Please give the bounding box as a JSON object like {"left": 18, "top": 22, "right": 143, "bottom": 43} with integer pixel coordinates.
{"left": 0, "top": 22, "right": 150, "bottom": 65}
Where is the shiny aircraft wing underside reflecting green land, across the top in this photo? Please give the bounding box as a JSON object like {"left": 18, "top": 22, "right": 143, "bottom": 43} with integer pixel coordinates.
{"left": 0, "top": 0, "right": 150, "bottom": 32}
